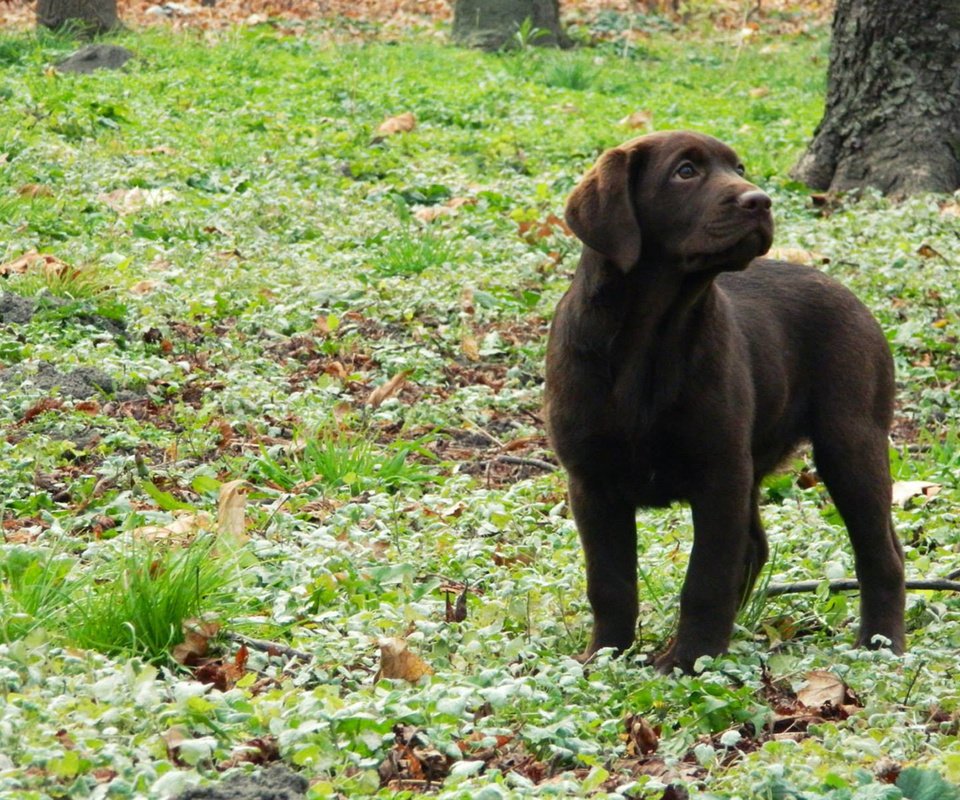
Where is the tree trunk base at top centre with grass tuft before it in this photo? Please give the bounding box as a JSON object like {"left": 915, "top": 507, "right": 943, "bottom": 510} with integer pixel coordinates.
{"left": 453, "top": 0, "right": 570, "bottom": 50}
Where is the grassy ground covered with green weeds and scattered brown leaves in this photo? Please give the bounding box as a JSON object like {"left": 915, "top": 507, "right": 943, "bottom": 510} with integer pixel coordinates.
{"left": 0, "top": 11, "right": 960, "bottom": 800}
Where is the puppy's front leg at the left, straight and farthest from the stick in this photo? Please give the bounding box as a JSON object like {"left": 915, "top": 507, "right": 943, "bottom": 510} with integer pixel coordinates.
{"left": 569, "top": 475, "right": 638, "bottom": 659}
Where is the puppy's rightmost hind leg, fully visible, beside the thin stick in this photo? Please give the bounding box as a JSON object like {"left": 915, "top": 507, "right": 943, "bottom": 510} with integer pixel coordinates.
{"left": 813, "top": 428, "right": 906, "bottom": 653}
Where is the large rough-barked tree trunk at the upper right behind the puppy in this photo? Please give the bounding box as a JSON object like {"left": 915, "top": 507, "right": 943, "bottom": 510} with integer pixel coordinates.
{"left": 793, "top": 0, "right": 960, "bottom": 196}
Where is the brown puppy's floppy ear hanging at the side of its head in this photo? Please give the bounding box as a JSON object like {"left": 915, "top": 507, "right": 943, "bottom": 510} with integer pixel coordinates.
{"left": 564, "top": 147, "right": 640, "bottom": 272}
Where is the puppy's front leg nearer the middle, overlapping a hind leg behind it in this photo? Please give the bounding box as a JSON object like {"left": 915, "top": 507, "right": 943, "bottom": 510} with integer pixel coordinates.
{"left": 656, "top": 474, "right": 751, "bottom": 672}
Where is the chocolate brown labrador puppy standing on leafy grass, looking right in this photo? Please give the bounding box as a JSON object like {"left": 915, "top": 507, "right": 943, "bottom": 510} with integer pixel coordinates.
{"left": 546, "top": 131, "right": 904, "bottom": 671}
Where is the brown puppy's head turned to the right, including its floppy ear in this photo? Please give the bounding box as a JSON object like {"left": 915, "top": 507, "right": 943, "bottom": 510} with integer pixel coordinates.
{"left": 566, "top": 131, "right": 773, "bottom": 272}
